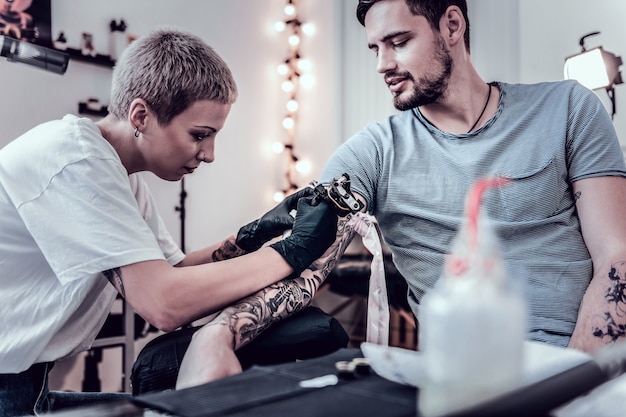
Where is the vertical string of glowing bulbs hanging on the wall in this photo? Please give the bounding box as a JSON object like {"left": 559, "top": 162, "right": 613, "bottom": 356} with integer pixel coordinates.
{"left": 272, "top": 0, "right": 315, "bottom": 202}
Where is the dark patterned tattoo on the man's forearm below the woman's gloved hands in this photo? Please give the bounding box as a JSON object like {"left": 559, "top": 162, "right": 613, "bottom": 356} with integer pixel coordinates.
{"left": 207, "top": 217, "right": 354, "bottom": 349}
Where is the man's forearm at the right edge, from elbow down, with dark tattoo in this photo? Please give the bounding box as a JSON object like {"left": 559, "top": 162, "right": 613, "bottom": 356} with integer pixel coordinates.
{"left": 569, "top": 261, "right": 626, "bottom": 353}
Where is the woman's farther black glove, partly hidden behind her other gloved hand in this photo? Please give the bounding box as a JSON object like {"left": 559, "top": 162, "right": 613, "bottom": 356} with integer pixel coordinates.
{"left": 237, "top": 187, "right": 313, "bottom": 252}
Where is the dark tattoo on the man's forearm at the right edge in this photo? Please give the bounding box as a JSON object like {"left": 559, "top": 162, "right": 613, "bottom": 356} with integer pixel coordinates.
{"left": 593, "top": 261, "right": 626, "bottom": 342}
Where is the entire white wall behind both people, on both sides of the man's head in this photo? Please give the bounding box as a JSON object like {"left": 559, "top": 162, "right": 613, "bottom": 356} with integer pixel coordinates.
{"left": 6, "top": 0, "right": 626, "bottom": 250}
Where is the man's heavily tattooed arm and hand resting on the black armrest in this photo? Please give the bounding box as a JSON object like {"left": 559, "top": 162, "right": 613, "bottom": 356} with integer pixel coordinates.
{"left": 176, "top": 213, "right": 354, "bottom": 389}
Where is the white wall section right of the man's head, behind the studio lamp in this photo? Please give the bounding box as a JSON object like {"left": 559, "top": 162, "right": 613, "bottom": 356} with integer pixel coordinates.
{"left": 468, "top": 0, "right": 626, "bottom": 149}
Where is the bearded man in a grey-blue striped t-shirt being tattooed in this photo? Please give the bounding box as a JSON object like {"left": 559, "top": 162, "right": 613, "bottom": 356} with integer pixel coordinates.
{"left": 173, "top": 0, "right": 626, "bottom": 385}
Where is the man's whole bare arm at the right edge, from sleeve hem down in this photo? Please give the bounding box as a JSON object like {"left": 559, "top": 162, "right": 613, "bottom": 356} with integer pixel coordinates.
{"left": 569, "top": 177, "right": 626, "bottom": 353}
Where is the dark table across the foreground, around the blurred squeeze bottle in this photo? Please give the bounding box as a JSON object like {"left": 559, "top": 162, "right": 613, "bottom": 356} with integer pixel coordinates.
{"left": 44, "top": 349, "right": 626, "bottom": 417}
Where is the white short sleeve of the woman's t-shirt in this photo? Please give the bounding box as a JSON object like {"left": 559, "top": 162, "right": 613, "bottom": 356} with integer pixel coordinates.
{"left": 17, "top": 158, "right": 164, "bottom": 283}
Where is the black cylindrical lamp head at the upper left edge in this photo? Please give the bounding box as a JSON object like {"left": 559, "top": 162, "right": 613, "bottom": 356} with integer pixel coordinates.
{"left": 0, "top": 35, "right": 70, "bottom": 74}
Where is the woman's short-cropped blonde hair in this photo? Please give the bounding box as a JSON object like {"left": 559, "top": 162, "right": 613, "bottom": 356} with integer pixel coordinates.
{"left": 109, "top": 28, "right": 237, "bottom": 126}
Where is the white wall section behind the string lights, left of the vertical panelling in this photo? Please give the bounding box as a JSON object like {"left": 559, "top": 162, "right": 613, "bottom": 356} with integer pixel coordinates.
{"left": 0, "top": 0, "right": 339, "bottom": 250}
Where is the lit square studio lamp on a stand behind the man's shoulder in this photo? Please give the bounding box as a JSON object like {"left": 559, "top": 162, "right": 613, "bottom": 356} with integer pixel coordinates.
{"left": 563, "top": 32, "right": 623, "bottom": 118}
